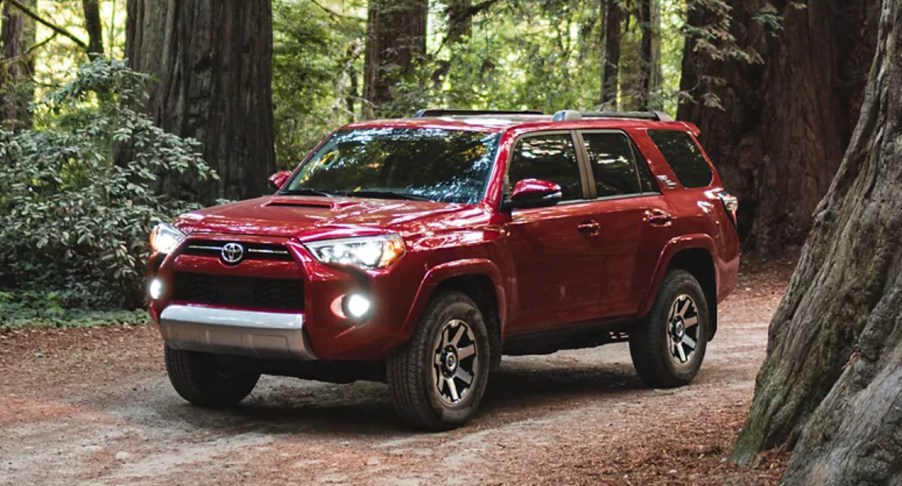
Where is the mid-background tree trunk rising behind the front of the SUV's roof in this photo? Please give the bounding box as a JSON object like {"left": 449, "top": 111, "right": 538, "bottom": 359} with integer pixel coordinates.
{"left": 364, "top": 0, "right": 429, "bottom": 115}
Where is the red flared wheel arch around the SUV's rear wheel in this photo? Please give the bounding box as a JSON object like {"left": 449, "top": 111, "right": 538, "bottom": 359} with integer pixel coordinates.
{"left": 639, "top": 235, "right": 718, "bottom": 340}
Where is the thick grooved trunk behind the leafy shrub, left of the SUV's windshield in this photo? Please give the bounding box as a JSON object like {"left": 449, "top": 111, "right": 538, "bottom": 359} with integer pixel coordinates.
{"left": 126, "top": 0, "right": 275, "bottom": 204}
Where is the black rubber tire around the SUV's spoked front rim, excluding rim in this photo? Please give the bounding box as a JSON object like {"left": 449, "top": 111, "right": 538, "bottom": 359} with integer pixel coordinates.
{"left": 386, "top": 291, "right": 492, "bottom": 431}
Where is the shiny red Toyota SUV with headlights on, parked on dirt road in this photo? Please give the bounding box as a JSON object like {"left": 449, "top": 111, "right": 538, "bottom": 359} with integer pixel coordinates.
{"left": 148, "top": 110, "right": 739, "bottom": 430}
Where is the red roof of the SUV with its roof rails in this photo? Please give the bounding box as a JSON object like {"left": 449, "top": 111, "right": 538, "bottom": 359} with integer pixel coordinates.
{"left": 343, "top": 115, "right": 698, "bottom": 133}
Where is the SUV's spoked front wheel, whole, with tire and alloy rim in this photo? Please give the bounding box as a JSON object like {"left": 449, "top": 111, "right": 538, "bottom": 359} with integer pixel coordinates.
{"left": 386, "top": 292, "right": 491, "bottom": 430}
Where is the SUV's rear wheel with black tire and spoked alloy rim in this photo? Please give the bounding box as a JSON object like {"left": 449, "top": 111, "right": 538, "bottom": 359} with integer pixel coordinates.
{"left": 630, "top": 270, "right": 709, "bottom": 388}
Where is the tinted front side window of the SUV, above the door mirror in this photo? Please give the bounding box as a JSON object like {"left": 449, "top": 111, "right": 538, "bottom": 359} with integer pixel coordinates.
{"left": 508, "top": 134, "right": 583, "bottom": 201}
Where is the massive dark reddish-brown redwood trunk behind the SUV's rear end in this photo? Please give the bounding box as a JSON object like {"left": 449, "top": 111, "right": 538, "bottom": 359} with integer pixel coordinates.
{"left": 678, "top": 0, "right": 878, "bottom": 253}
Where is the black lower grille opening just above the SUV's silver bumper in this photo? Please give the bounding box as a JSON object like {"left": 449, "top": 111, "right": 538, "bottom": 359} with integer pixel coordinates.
{"left": 173, "top": 272, "right": 304, "bottom": 311}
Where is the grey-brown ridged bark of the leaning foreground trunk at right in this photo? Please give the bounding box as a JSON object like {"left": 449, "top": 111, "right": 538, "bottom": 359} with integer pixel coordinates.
{"left": 733, "top": 0, "right": 902, "bottom": 485}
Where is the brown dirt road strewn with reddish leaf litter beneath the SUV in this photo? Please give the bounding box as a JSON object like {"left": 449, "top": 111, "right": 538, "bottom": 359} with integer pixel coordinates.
{"left": 0, "top": 261, "right": 794, "bottom": 485}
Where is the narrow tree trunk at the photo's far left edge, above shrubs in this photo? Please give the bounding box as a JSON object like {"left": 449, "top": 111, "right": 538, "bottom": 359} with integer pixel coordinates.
{"left": 0, "top": 0, "right": 36, "bottom": 130}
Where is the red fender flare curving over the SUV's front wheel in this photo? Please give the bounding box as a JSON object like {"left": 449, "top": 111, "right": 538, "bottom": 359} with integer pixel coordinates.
{"left": 401, "top": 258, "right": 507, "bottom": 339}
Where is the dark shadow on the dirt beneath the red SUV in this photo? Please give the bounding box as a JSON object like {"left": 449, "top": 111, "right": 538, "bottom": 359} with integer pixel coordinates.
{"left": 159, "top": 360, "right": 643, "bottom": 439}
